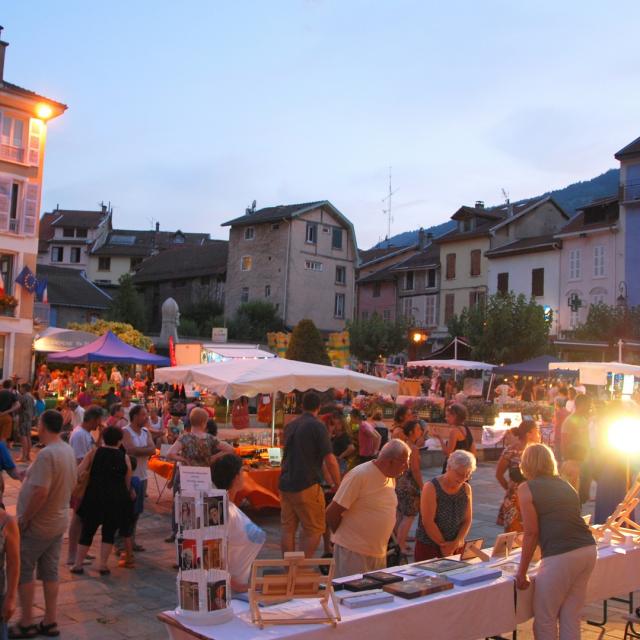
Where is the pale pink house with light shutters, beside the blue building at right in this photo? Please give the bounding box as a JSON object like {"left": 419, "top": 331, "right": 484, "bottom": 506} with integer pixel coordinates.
{"left": 556, "top": 196, "right": 624, "bottom": 331}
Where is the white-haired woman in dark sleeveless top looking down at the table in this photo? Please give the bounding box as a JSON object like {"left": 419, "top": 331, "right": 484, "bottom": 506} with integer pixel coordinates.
{"left": 415, "top": 450, "right": 476, "bottom": 561}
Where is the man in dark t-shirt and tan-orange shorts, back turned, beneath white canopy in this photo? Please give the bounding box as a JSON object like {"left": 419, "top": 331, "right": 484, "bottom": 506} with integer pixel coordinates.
{"left": 280, "top": 392, "right": 340, "bottom": 558}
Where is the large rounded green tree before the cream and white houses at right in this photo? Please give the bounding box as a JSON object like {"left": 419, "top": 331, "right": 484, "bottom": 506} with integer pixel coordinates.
{"left": 448, "top": 292, "right": 551, "bottom": 364}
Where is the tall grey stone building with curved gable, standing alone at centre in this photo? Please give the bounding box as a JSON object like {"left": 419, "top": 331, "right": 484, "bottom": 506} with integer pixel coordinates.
{"left": 223, "top": 200, "right": 358, "bottom": 332}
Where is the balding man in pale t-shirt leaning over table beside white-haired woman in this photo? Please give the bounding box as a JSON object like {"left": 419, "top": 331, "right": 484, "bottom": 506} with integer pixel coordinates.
{"left": 326, "top": 440, "right": 411, "bottom": 578}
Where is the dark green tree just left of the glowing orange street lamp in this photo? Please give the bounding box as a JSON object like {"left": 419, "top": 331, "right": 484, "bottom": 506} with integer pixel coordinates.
{"left": 347, "top": 313, "right": 410, "bottom": 362}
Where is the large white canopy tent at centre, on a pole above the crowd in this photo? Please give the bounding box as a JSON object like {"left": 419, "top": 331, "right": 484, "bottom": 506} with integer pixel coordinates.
{"left": 154, "top": 358, "right": 398, "bottom": 438}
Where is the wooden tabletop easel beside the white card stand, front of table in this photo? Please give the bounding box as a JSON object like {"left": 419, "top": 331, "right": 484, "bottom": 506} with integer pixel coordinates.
{"left": 248, "top": 551, "right": 340, "bottom": 629}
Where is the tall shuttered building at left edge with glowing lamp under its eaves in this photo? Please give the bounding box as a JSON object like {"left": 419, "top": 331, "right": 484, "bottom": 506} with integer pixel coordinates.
{"left": 0, "top": 28, "right": 67, "bottom": 380}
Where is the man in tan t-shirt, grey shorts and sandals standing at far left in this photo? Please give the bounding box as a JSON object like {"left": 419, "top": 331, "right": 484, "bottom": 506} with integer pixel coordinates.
{"left": 10, "top": 410, "right": 77, "bottom": 637}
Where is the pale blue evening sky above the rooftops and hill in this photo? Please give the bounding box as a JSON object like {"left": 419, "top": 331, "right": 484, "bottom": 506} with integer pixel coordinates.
{"left": 0, "top": 0, "right": 640, "bottom": 248}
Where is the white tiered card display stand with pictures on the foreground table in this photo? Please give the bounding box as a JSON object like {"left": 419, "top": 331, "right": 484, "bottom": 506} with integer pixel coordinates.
{"left": 175, "top": 467, "right": 233, "bottom": 626}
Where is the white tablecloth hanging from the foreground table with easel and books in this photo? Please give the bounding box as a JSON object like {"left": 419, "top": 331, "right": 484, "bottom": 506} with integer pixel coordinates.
{"left": 165, "top": 578, "right": 515, "bottom": 640}
